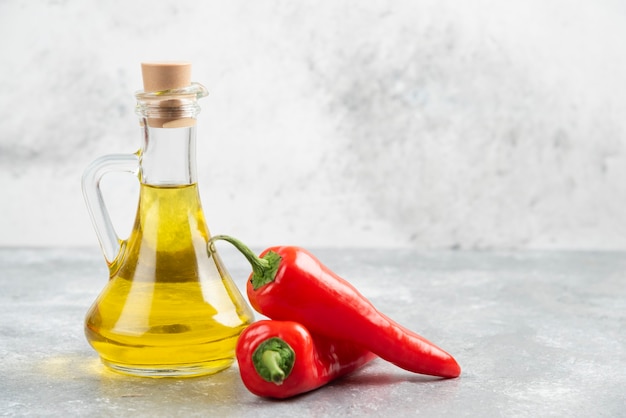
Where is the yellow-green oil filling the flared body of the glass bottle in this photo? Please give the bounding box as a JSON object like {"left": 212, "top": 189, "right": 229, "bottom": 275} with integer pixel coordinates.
{"left": 85, "top": 184, "right": 253, "bottom": 376}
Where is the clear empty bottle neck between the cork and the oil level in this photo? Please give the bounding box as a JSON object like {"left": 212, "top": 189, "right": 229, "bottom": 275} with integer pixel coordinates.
{"left": 139, "top": 119, "right": 197, "bottom": 186}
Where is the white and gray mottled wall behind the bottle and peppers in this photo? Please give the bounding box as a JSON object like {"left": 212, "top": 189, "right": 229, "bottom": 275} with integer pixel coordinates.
{"left": 0, "top": 0, "right": 626, "bottom": 249}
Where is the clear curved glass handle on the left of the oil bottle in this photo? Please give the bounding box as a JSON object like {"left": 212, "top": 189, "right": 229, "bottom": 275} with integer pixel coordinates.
{"left": 82, "top": 154, "right": 139, "bottom": 266}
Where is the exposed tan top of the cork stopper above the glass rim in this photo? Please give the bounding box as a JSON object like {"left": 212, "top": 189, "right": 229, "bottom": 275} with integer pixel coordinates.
{"left": 141, "top": 62, "right": 191, "bottom": 92}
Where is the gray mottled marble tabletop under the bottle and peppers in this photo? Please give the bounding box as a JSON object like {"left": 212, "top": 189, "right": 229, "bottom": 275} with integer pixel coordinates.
{"left": 0, "top": 248, "right": 626, "bottom": 417}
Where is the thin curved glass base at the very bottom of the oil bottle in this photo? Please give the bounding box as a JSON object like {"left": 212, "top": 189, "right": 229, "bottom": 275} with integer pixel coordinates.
{"left": 100, "top": 358, "right": 234, "bottom": 378}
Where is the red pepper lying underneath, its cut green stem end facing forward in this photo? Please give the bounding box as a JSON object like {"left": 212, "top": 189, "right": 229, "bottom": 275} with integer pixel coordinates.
{"left": 236, "top": 320, "right": 376, "bottom": 399}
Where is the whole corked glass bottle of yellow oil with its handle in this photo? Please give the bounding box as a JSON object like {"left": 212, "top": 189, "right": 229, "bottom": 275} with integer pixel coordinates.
{"left": 83, "top": 63, "right": 253, "bottom": 377}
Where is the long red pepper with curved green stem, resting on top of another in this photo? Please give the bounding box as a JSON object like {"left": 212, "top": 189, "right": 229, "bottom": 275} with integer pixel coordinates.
{"left": 212, "top": 235, "right": 461, "bottom": 377}
